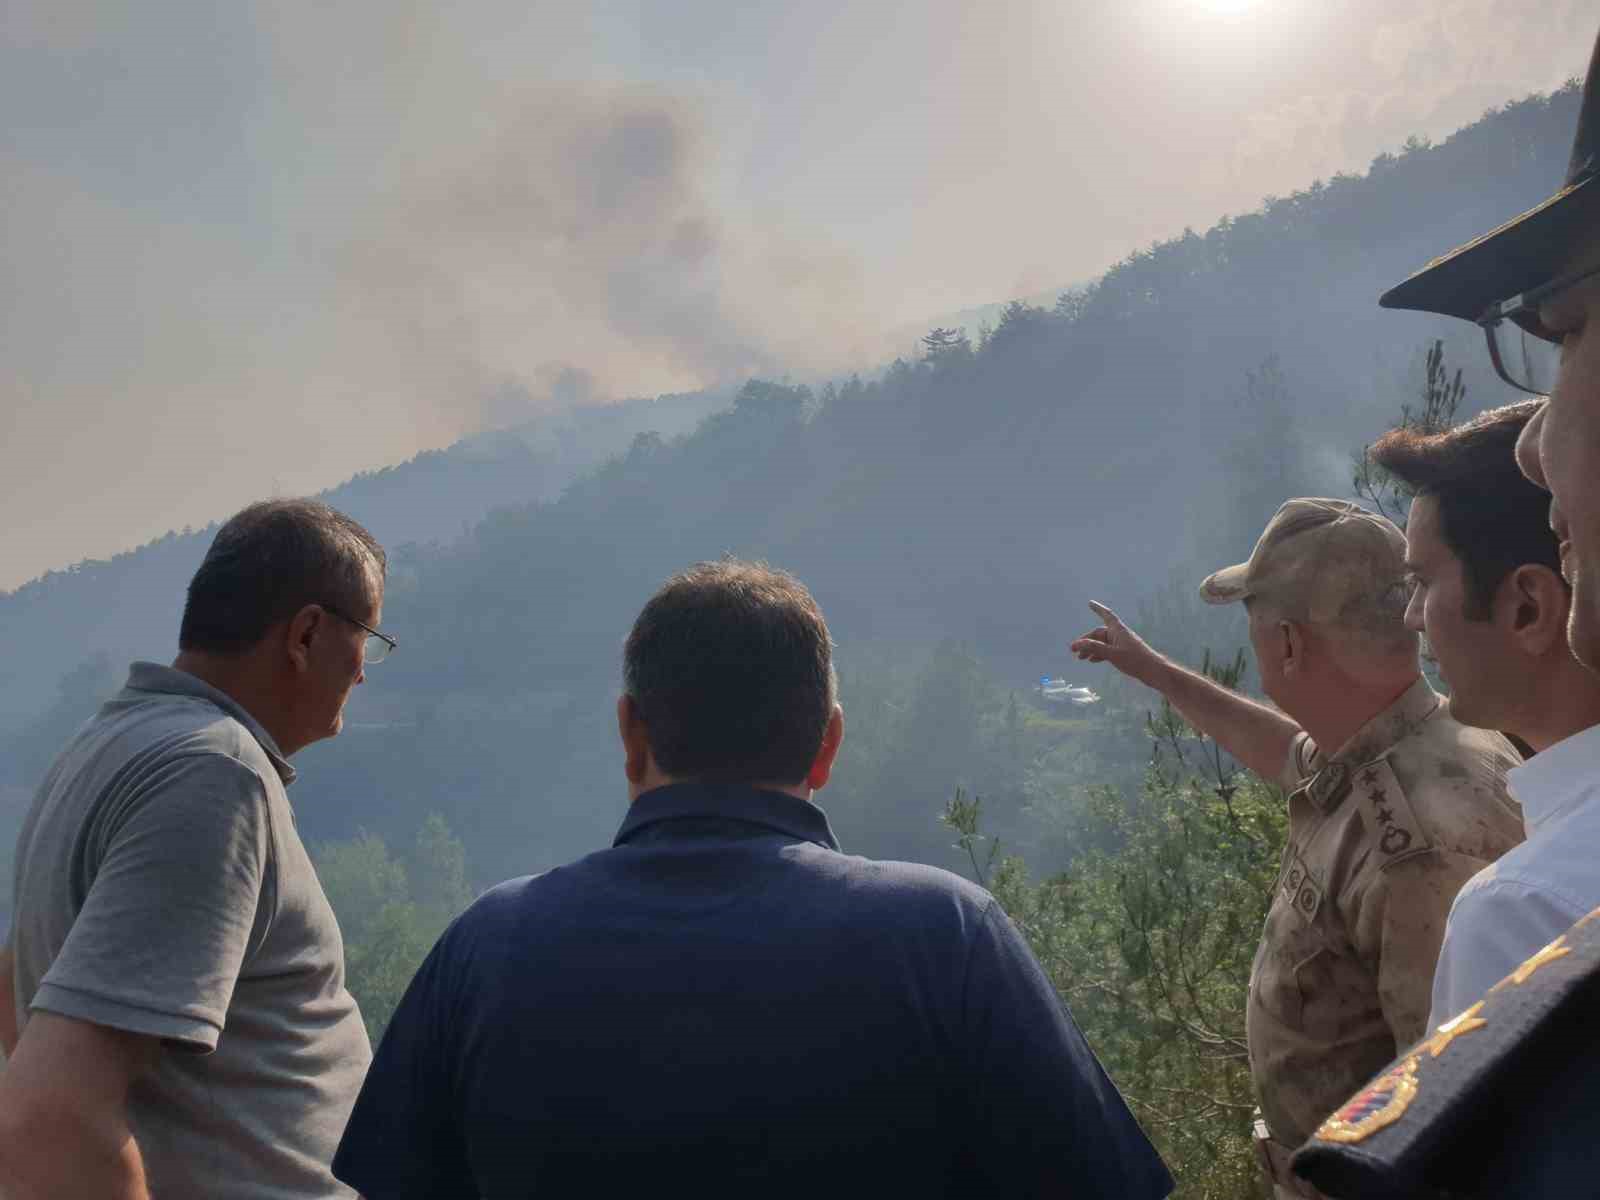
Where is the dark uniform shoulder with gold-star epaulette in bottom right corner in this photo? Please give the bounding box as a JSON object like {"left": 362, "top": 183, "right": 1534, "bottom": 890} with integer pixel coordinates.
{"left": 1293, "top": 910, "right": 1600, "bottom": 1200}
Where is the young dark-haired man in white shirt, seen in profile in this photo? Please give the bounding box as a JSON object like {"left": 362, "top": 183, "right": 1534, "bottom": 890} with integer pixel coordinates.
{"left": 1371, "top": 400, "right": 1600, "bottom": 1029}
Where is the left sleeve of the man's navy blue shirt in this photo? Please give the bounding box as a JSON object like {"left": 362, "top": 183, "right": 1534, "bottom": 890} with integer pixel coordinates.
{"left": 333, "top": 920, "right": 478, "bottom": 1200}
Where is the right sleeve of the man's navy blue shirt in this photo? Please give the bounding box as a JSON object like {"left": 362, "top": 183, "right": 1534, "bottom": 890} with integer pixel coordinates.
{"left": 962, "top": 902, "right": 1173, "bottom": 1200}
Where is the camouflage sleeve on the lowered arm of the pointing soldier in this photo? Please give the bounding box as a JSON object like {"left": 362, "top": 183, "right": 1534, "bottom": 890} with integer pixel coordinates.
{"left": 1352, "top": 848, "right": 1486, "bottom": 1050}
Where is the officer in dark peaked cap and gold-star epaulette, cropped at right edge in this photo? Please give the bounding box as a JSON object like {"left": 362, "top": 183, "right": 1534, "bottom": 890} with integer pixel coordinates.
{"left": 1294, "top": 21, "right": 1600, "bottom": 1200}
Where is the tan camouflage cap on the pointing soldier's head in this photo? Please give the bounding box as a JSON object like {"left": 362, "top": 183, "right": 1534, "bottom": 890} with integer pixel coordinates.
{"left": 1200, "top": 498, "right": 1405, "bottom": 621}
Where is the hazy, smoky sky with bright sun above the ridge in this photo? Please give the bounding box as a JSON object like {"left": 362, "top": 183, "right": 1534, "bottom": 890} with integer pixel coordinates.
{"left": 0, "top": 0, "right": 1597, "bottom": 587}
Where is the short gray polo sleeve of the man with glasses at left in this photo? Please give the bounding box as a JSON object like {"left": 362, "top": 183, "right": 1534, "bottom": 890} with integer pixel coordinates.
{"left": 29, "top": 754, "right": 274, "bottom": 1051}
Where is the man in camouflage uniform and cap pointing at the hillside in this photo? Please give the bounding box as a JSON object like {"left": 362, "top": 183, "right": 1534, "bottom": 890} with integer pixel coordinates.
{"left": 1072, "top": 499, "right": 1522, "bottom": 1197}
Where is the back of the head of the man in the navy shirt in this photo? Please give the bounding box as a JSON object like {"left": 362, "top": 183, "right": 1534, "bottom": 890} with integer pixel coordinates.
{"left": 622, "top": 558, "right": 835, "bottom": 784}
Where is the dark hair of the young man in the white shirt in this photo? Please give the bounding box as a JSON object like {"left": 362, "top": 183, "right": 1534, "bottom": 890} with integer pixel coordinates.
{"left": 1368, "top": 400, "right": 1562, "bottom": 621}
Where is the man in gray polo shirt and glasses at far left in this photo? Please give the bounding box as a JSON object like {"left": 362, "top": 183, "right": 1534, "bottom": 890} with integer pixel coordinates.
{"left": 0, "top": 501, "right": 394, "bottom": 1200}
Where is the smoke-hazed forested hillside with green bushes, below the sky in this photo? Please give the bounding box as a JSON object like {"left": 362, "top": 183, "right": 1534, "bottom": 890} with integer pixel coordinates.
{"left": 0, "top": 80, "right": 1578, "bottom": 1195}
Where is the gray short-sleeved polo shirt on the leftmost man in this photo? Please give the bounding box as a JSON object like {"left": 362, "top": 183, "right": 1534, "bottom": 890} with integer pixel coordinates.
{"left": 10, "top": 662, "right": 371, "bottom": 1200}
